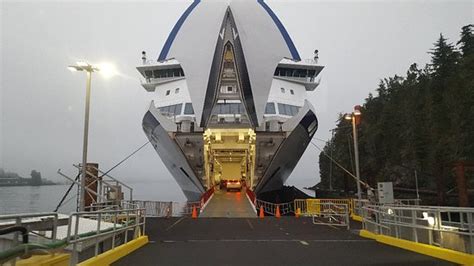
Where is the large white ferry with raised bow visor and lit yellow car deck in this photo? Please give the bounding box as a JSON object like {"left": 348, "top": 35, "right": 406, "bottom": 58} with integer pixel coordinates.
{"left": 137, "top": 1, "right": 323, "bottom": 200}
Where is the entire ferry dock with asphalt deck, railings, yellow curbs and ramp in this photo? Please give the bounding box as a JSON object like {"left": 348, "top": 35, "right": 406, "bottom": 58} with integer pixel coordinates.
{"left": 0, "top": 196, "right": 474, "bottom": 266}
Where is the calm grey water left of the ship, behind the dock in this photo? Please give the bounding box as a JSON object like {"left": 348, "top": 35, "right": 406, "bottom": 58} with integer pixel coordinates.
{"left": 0, "top": 180, "right": 186, "bottom": 215}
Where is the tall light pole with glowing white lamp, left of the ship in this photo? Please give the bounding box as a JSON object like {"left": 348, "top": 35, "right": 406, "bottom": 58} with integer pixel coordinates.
{"left": 68, "top": 62, "right": 99, "bottom": 211}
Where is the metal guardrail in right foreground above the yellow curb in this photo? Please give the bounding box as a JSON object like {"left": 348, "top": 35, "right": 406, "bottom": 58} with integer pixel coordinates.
{"left": 362, "top": 205, "right": 474, "bottom": 254}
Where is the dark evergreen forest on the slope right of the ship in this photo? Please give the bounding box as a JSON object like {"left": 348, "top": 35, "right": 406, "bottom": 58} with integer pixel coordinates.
{"left": 318, "top": 24, "right": 474, "bottom": 206}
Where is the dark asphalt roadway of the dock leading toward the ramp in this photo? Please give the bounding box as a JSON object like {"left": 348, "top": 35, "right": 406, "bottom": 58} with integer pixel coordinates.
{"left": 113, "top": 217, "right": 452, "bottom": 265}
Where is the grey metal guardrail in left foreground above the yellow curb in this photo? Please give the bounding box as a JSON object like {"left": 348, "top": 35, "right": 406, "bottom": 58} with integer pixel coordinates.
{"left": 0, "top": 205, "right": 145, "bottom": 265}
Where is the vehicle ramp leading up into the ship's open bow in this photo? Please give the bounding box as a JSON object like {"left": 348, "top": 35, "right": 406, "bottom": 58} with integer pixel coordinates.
{"left": 199, "top": 188, "right": 257, "bottom": 218}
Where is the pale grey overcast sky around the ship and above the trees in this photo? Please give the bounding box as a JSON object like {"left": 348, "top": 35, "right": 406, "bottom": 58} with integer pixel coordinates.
{"left": 0, "top": 0, "right": 474, "bottom": 194}
